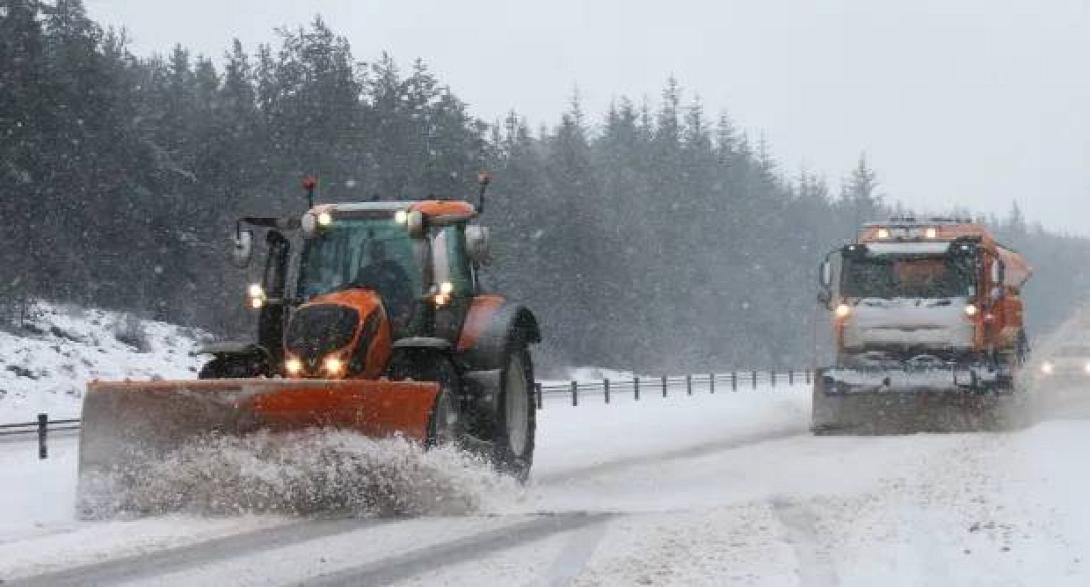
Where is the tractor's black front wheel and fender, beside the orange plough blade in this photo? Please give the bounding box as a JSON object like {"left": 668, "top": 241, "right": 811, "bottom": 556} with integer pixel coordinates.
{"left": 390, "top": 351, "right": 464, "bottom": 448}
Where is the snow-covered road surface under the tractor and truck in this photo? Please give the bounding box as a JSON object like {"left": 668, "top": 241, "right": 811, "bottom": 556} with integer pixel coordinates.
{"left": 0, "top": 386, "right": 1090, "bottom": 585}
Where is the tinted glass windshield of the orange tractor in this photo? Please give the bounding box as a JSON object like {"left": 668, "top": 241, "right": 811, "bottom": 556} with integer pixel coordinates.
{"left": 296, "top": 217, "right": 423, "bottom": 314}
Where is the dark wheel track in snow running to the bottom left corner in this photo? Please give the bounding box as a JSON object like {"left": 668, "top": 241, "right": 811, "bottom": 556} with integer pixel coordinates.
{"left": 4, "top": 518, "right": 403, "bottom": 587}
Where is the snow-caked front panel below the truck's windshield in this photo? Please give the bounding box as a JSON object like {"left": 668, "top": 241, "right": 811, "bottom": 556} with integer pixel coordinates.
{"left": 843, "top": 297, "right": 973, "bottom": 350}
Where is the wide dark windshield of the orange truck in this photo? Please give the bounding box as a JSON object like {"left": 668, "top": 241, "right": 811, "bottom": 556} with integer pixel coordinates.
{"left": 840, "top": 255, "right": 976, "bottom": 298}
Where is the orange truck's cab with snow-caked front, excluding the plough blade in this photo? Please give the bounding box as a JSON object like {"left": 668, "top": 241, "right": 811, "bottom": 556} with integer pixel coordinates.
{"left": 819, "top": 218, "right": 1029, "bottom": 387}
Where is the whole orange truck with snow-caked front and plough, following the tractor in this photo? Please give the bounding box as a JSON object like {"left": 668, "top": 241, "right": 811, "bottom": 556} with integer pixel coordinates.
{"left": 812, "top": 218, "right": 1030, "bottom": 433}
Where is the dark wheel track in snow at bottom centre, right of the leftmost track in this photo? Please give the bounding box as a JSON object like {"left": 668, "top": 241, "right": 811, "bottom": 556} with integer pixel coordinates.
{"left": 303, "top": 513, "right": 616, "bottom": 586}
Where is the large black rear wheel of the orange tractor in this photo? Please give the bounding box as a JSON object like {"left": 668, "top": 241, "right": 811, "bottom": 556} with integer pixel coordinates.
{"left": 493, "top": 342, "right": 537, "bottom": 482}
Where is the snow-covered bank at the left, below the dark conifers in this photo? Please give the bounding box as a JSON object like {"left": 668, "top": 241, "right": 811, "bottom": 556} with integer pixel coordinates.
{"left": 0, "top": 303, "right": 207, "bottom": 424}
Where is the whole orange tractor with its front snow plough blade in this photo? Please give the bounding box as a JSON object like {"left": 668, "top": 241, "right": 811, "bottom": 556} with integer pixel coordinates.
{"left": 80, "top": 175, "right": 541, "bottom": 479}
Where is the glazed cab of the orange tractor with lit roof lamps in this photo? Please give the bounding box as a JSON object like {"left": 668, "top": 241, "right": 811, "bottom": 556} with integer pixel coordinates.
{"left": 294, "top": 200, "right": 487, "bottom": 342}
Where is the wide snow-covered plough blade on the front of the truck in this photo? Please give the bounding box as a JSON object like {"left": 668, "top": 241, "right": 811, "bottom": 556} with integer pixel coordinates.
{"left": 811, "top": 369, "right": 1028, "bottom": 435}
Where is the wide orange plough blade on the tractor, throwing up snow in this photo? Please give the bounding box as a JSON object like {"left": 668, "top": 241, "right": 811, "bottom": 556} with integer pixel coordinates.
{"left": 80, "top": 379, "right": 439, "bottom": 479}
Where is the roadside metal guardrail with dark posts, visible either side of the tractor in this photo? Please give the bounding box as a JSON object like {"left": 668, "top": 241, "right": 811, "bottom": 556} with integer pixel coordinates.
{"left": 0, "top": 369, "right": 813, "bottom": 458}
